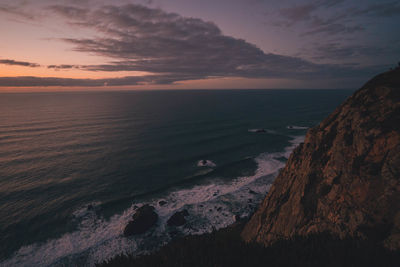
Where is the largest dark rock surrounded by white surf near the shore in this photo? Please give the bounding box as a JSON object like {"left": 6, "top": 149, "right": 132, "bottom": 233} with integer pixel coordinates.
{"left": 124, "top": 205, "right": 158, "bottom": 236}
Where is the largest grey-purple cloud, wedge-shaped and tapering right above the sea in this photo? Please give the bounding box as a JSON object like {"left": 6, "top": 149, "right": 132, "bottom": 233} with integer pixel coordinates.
{"left": 43, "top": 5, "right": 378, "bottom": 83}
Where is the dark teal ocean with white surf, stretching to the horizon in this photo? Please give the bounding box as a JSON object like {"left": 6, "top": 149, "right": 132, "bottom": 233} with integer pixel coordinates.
{"left": 0, "top": 90, "right": 353, "bottom": 266}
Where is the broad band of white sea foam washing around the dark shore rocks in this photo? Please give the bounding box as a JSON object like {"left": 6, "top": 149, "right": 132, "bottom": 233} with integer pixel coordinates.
{"left": 0, "top": 136, "right": 304, "bottom": 266}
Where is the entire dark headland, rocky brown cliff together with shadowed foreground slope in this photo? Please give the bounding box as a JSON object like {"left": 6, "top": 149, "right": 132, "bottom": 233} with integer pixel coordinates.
{"left": 99, "top": 68, "right": 400, "bottom": 267}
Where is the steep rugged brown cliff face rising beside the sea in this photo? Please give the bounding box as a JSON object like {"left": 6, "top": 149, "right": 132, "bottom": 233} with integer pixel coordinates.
{"left": 242, "top": 68, "right": 400, "bottom": 249}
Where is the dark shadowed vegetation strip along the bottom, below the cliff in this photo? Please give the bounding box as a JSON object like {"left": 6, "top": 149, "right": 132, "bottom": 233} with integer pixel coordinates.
{"left": 97, "top": 224, "right": 400, "bottom": 267}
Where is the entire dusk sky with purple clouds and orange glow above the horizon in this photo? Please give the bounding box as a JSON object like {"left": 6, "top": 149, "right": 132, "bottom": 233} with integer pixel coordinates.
{"left": 0, "top": 0, "right": 400, "bottom": 92}
